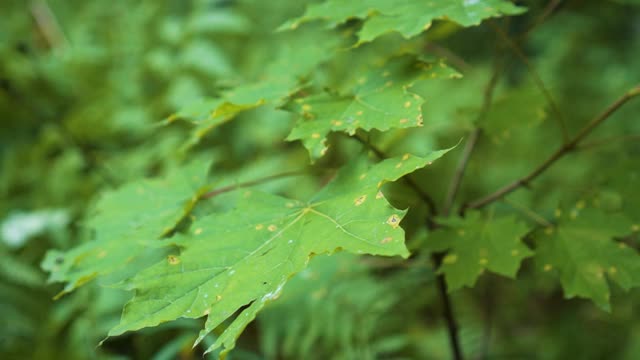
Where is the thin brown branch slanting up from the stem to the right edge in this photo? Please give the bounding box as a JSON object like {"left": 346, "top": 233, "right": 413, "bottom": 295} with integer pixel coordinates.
{"left": 463, "top": 85, "right": 640, "bottom": 210}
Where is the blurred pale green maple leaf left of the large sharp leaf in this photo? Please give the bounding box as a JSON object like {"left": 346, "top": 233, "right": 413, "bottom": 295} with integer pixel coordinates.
{"left": 42, "top": 159, "right": 211, "bottom": 296}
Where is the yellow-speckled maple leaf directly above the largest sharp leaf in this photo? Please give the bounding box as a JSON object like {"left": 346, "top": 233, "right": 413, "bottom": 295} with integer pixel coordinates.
{"left": 287, "top": 56, "right": 460, "bottom": 161}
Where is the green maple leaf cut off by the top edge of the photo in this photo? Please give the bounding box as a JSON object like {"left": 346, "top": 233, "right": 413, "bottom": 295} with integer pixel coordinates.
{"left": 280, "top": 0, "right": 525, "bottom": 43}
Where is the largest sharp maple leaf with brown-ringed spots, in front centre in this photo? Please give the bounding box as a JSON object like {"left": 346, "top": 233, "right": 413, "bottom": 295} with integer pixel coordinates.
{"left": 109, "top": 150, "right": 448, "bottom": 354}
